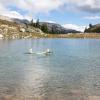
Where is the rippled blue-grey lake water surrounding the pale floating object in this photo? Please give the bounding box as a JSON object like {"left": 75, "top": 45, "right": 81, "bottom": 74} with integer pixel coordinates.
{"left": 0, "top": 39, "right": 100, "bottom": 100}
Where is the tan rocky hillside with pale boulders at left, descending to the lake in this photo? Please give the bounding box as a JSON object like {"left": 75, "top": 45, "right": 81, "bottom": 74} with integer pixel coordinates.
{"left": 0, "top": 16, "right": 44, "bottom": 39}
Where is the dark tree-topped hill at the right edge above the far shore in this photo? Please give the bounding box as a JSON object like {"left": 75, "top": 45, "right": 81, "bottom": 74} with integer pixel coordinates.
{"left": 85, "top": 24, "right": 100, "bottom": 33}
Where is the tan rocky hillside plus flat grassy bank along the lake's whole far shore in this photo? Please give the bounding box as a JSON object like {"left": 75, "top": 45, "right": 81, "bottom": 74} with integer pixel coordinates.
{"left": 0, "top": 19, "right": 100, "bottom": 39}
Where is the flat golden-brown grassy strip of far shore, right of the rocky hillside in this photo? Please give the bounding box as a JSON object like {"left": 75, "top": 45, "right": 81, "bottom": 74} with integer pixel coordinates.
{"left": 31, "top": 33, "right": 100, "bottom": 39}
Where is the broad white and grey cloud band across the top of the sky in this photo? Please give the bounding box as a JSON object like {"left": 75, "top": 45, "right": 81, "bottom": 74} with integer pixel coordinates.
{"left": 0, "top": 0, "right": 100, "bottom": 13}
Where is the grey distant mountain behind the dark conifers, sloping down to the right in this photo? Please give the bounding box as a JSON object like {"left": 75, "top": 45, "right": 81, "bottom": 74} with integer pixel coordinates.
{"left": 39, "top": 22, "right": 80, "bottom": 34}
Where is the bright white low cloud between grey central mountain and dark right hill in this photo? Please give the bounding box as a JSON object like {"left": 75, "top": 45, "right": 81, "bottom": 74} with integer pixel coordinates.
{"left": 62, "top": 24, "right": 86, "bottom": 32}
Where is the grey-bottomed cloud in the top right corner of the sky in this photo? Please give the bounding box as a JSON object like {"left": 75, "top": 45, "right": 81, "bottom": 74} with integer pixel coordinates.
{"left": 65, "top": 0, "right": 100, "bottom": 13}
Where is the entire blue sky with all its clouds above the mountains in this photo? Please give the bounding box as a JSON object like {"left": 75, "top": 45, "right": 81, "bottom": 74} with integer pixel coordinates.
{"left": 0, "top": 0, "right": 100, "bottom": 31}
